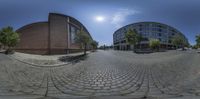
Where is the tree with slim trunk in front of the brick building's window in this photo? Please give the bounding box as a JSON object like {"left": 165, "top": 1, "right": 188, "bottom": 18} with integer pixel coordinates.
{"left": 75, "top": 29, "right": 91, "bottom": 55}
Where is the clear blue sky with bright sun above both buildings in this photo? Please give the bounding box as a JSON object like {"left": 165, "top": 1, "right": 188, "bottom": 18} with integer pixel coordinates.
{"left": 0, "top": 0, "right": 200, "bottom": 45}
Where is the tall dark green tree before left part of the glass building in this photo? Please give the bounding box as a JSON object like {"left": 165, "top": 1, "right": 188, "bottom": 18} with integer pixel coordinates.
{"left": 125, "top": 29, "right": 141, "bottom": 52}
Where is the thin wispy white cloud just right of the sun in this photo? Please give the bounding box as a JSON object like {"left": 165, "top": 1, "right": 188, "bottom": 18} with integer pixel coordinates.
{"left": 111, "top": 9, "right": 138, "bottom": 28}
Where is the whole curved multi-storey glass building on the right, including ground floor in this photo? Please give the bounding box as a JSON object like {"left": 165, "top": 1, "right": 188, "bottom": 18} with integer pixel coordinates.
{"left": 113, "top": 22, "right": 188, "bottom": 50}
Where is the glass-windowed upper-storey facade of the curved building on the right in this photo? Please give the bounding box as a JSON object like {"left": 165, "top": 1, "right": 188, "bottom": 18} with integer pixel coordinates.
{"left": 113, "top": 22, "right": 187, "bottom": 49}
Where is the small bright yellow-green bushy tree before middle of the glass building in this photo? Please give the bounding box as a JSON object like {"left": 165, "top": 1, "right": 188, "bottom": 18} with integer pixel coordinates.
{"left": 149, "top": 39, "right": 160, "bottom": 51}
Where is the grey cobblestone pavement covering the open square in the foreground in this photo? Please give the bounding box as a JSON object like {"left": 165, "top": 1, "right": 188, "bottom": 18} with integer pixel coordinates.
{"left": 0, "top": 51, "right": 200, "bottom": 99}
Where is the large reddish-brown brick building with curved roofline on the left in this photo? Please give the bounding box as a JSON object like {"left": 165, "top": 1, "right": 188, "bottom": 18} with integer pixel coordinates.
{"left": 15, "top": 13, "right": 92, "bottom": 54}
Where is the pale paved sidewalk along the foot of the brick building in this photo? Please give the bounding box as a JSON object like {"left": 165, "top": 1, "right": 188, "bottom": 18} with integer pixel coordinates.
{"left": 9, "top": 51, "right": 90, "bottom": 67}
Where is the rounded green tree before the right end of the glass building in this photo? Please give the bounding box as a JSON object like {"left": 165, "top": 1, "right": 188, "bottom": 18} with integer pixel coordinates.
{"left": 171, "top": 35, "right": 189, "bottom": 50}
